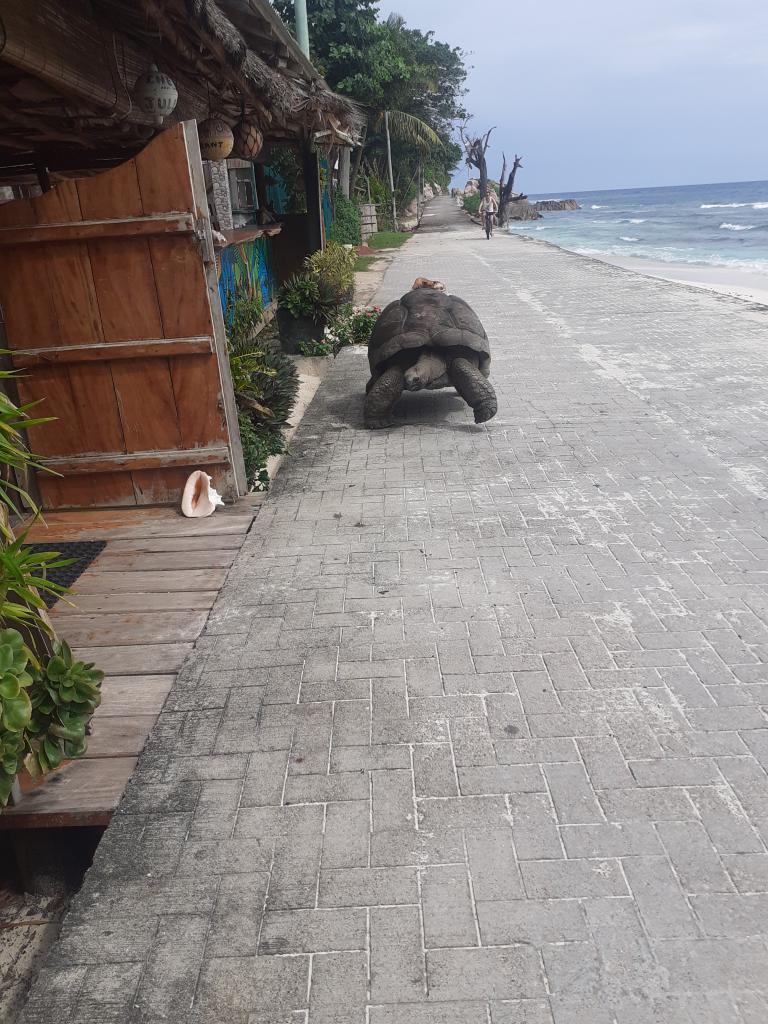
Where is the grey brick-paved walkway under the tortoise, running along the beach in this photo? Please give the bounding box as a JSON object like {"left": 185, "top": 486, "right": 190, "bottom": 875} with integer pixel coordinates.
{"left": 20, "top": 201, "right": 768, "bottom": 1024}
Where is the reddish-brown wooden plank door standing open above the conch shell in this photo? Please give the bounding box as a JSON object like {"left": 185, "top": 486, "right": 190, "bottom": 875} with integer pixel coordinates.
{"left": 0, "top": 121, "right": 245, "bottom": 509}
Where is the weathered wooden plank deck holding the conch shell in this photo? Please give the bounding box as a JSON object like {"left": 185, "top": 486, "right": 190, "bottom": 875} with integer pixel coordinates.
{"left": 0, "top": 495, "right": 263, "bottom": 829}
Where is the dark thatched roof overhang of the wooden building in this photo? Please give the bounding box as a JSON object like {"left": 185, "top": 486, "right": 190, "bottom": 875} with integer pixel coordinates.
{"left": 0, "top": 0, "right": 362, "bottom": 180}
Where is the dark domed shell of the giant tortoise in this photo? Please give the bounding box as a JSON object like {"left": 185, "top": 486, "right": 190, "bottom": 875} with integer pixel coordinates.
{"left": 368, "top": 288, "right": 490, "bottom": 378}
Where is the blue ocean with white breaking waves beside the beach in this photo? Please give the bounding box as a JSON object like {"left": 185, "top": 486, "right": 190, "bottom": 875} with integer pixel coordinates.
{"left": 509, "top": 181, "right": 768, "bottom": 273}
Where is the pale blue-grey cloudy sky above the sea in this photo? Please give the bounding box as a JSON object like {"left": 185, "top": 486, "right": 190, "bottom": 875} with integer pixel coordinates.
{"left": 380, "top": 0, "right": 768, "bottom": 195}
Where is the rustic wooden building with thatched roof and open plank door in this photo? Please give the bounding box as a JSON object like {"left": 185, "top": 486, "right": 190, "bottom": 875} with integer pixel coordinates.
{"left": 0, "top": 0, "right": 359, "bottom": 509}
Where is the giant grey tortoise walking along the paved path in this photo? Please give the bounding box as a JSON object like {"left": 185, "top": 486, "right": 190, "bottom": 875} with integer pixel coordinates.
{"left": 365, "top": 279, "right": 497, "bottom": 430}
